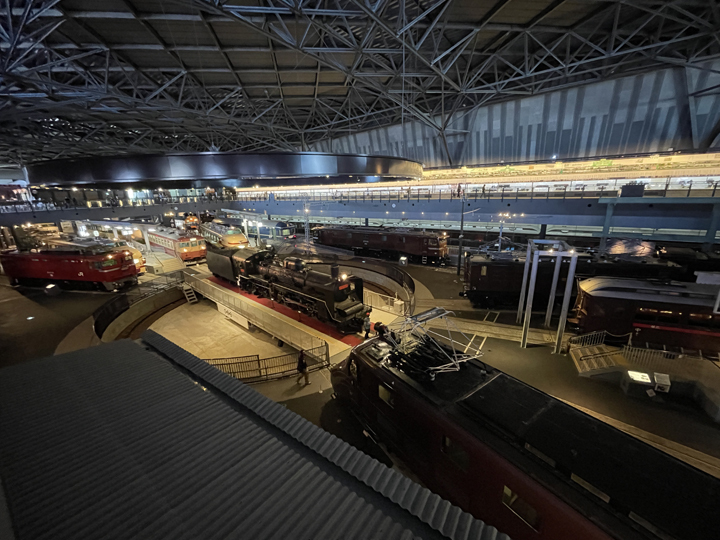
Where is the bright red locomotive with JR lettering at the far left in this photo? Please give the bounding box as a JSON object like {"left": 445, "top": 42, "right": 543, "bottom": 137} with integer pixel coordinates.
{"left": 0, "top": 248, "right": 137, "bottom": 291}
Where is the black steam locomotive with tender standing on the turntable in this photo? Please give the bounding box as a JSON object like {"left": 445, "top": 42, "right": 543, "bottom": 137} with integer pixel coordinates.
{"left": 207, "top": 248, "right": 372, "bottom": 333}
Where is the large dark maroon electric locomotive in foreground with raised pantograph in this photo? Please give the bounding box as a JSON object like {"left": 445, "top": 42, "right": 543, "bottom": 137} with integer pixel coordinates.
{"left": 331, "top": 326, "right": 720, "bottom": 540}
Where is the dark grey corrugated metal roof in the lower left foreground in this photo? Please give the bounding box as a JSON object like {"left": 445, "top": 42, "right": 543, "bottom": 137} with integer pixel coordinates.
{"left": 0, "top": 332, "right": 507, "bottom": 540}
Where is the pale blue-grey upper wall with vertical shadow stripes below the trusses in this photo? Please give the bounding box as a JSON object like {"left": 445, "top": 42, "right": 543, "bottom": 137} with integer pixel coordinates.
{"left": 312, "top": 61, "right": 720, "bottom": 167}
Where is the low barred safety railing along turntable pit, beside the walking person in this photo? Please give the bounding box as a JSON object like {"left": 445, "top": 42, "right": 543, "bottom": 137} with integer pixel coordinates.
{"left": 204, "top": 344, "right": 330, "bottom": 383}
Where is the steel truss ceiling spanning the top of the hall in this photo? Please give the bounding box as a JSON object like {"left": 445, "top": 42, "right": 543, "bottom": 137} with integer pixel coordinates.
{"left": 0, "top": 0, "right": 720, "bottom": 163}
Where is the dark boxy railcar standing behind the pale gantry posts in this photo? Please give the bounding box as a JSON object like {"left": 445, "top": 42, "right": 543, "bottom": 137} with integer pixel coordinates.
{"left": 461, "top": 251, "right": 685, "bottom": 308}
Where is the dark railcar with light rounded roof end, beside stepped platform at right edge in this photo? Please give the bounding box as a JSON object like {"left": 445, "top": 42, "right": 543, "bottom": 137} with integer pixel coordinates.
{"left": 568, "top": 277, "right": 720, "bottom": 356}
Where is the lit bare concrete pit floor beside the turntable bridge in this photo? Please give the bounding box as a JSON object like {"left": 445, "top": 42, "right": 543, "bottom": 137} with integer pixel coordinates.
{"left": 150, "top": 300, "right": 294, "bottom": 359}
